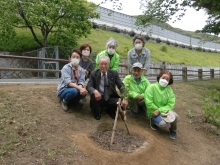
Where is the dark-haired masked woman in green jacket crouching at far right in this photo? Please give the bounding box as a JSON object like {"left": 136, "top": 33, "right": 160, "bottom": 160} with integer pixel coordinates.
{"left": 144, "top": 71, "right": 178, "bottom": 139}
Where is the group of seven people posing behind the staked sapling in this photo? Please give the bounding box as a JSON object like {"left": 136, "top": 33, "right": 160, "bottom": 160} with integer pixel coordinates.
{"left": 57, "top": 35, "right": 178, "bottom": 139}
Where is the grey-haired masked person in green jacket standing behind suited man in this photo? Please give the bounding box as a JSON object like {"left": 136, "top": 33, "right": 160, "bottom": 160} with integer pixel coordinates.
{"left": 95, "top": 37, "right": 120, "bottom": 70}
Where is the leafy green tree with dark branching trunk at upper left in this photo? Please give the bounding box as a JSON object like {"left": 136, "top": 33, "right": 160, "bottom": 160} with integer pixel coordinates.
{"left": 0, "top": 0, "right": 99, "bottom": 47}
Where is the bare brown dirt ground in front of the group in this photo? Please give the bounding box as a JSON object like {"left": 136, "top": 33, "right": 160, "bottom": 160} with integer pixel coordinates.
{"left": 0, "top": 80, "right": 220, "bottom": 165}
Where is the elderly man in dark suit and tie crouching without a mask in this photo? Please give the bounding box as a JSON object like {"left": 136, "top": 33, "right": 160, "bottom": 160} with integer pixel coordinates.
{"left": 86, "top": 56, "right": 127, "bottom": 120}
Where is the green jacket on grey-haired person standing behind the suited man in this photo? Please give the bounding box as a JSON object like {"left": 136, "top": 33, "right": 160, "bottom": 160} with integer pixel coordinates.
{"left": 95, "top": 50, "right": 120, "bottom": 70}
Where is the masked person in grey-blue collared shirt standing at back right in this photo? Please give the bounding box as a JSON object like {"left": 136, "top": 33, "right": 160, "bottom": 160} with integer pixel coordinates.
{"left": 128, "top": 35, "right": 150, "bottom": 75}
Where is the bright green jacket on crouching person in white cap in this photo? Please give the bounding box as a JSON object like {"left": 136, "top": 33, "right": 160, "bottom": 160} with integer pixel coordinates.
{"left": 123, "top": 74, "right": 150, "bottom": 99}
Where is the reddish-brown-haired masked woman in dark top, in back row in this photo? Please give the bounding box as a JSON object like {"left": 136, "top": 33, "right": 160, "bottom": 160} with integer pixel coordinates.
{"left": 79, "top": 44, "right": 93, "bottom": 79}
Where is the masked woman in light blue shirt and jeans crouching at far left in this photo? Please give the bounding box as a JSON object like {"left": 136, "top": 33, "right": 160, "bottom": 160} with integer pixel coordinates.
{"left": 57, "top": 50, "right": 88, "bottom": 111}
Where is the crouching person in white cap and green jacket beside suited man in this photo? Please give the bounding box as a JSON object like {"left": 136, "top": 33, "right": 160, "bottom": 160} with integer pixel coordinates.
{"left": 123, "top": 62, "right": 150, "bottom": 117}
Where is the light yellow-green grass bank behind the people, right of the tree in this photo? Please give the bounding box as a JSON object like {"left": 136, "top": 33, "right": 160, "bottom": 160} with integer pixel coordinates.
{"left": 78, "top": 29, "right": 220, "bottom": 66}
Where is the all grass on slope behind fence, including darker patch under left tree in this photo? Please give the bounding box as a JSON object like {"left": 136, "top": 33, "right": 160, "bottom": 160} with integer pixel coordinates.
{"left": 0, "top": 29, "right": 220, "bottom": 66}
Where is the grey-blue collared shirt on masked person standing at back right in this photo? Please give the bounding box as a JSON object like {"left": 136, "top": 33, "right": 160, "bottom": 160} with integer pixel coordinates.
{"left": 128, "top": 48, "right": 150, "bottom": 70}
